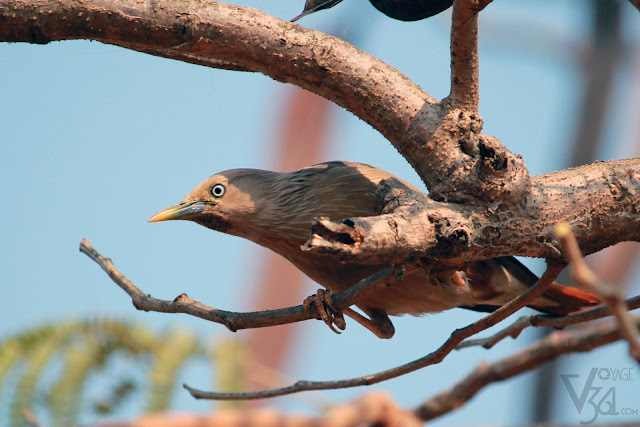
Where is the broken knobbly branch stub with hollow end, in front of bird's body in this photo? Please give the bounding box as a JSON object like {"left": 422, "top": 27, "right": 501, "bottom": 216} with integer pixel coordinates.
{"left": 302, "top": 175, "right": 482, "bottom": 267}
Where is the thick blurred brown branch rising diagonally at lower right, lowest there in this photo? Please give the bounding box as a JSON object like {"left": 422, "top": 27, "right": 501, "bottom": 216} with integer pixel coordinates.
{"left": 415, "top": 316, "right": 640, "bottom": 420}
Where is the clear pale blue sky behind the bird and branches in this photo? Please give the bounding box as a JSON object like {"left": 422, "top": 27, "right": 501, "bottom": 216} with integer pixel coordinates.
{"left": 0, "top": 0, "right": 640, "bottom": 425}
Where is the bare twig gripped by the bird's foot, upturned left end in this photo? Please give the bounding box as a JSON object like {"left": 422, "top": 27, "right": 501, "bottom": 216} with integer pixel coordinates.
{"left": 80, "top": 239, "right": 417, "bottom": 332}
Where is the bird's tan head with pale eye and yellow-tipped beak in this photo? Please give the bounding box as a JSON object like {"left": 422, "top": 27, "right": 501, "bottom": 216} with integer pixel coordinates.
{"left": 149, "top": 169, "right": 273, "bottom": 235}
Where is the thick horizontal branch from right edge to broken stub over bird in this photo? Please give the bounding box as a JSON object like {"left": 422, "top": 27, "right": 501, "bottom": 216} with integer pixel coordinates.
{"left": 305, "top": 158, "right": 640, "bottom": 268}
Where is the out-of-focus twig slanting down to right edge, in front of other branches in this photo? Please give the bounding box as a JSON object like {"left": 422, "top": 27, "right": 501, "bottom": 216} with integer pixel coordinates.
{"left": 556, "top": 223, "right": 640, "bottom": 363}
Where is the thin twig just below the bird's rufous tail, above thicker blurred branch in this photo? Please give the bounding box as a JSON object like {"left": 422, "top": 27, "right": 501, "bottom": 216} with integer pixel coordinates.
{"left": 456, "top": 296, "right": 640, "bottom": 350}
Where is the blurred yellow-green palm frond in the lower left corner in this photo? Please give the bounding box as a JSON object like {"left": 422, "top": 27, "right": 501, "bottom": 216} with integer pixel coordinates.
{"left": 0, "top": 319, "right": 242, "bottom": 426}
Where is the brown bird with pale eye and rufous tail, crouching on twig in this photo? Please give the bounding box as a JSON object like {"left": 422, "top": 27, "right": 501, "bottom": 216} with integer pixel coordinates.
{"left": 149, "top": 161, "right": 600, "bottom": 338}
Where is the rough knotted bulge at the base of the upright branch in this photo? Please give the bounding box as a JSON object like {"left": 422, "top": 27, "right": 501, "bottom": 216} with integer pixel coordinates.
{"left": 405, "top": 108, "right": 529, "bottom": 205}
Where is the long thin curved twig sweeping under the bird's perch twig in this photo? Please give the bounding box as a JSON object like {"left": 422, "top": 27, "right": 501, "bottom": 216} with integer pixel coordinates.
{"left": 184, "top": 263, "right": 562, "bottom": 400}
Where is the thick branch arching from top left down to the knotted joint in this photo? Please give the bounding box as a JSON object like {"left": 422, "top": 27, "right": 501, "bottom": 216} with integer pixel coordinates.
{"left": 0, "top": 0, "right": 528, "bottom": 200}
